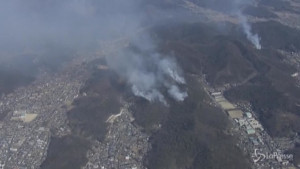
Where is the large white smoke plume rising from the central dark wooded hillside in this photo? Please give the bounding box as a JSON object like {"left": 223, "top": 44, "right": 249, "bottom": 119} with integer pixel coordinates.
{"left": 106, "top": 34, "right": 187, "bottom": 105}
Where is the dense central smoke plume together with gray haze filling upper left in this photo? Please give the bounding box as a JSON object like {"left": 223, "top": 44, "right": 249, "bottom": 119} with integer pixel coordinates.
{"left": 0, "top": 0, "right": 187, "bottom": 104}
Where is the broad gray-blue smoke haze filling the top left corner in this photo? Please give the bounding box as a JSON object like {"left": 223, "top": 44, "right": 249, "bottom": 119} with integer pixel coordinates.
{"left": 0, "top": 0, "right": 141, "bottom": 50}
